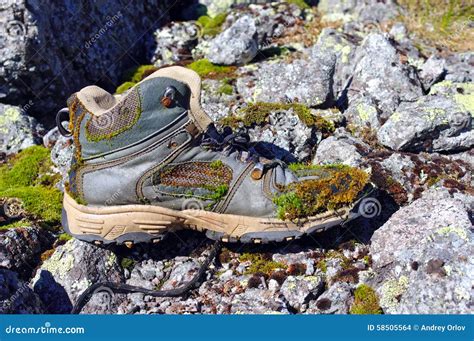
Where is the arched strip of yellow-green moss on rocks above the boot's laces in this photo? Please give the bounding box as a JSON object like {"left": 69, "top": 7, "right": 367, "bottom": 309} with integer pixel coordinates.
{"left": 222, "top": 102, "right": 334, "bottom": 133}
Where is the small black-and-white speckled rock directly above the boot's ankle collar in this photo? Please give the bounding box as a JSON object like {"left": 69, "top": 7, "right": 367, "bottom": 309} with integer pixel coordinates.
{"left": 152, "top": 21, "right": 200, "bottom": 67}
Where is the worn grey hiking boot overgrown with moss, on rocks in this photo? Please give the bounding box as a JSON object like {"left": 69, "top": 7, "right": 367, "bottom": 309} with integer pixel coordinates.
{"left": 58, "top": 67, "right": 370, "bottom": 246}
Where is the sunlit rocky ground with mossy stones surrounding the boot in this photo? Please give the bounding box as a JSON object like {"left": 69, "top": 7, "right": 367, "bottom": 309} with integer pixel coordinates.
{"left": 0, "top": 0, "right": 474, "bottom": 314}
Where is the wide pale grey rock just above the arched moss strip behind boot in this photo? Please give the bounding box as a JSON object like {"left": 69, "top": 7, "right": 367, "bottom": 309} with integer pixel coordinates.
{"left": 237, "top": 51, "right": 336, "bottom": 106}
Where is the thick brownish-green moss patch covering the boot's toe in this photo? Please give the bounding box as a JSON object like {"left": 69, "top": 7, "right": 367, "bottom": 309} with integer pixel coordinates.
{"left": 273, "top": 165, "right": 369, "bottom": 220}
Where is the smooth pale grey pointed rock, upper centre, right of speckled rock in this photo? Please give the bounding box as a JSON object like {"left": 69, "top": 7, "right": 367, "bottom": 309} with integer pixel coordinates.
{"left": 206, "top": 16, "right": 258, "bottom": 65}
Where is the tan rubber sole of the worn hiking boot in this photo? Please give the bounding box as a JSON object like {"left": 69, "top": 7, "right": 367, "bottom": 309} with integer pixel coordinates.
{"left": 62, "top": 193, "right": 368, "bottom": 246}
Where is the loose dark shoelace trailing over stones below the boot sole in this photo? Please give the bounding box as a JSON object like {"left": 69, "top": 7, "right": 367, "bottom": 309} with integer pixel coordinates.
{"left": 71, "top": 241, "right": 222, "bottom": 314}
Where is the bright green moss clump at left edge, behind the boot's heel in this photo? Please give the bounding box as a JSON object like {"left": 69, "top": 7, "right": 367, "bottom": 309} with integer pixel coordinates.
{"left": 0, "top": 146, "right": 62, "bottom": 227}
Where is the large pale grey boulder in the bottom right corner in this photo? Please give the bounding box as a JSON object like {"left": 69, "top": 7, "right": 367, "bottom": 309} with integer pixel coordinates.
{"left": 370, "top": 190, "right": 474, "bottom": 314}
